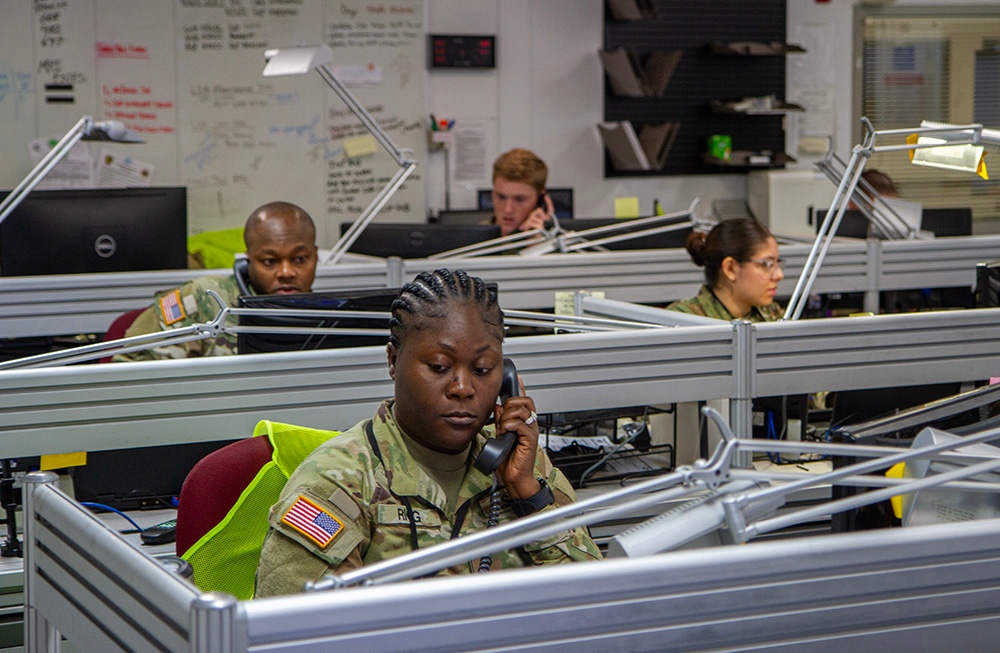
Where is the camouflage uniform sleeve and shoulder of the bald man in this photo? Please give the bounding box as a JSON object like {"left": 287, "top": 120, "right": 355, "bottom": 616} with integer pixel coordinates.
{"left": 112, "top": 275, "right": 241, "bottom": 363}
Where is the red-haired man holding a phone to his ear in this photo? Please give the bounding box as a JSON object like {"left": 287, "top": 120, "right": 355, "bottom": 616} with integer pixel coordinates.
{"left": 493, "top": 148, "right": 555, "bottom": 236}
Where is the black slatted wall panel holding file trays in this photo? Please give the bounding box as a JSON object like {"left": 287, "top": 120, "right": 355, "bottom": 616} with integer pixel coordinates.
{"left": 604, "top": 0, "right": 791, "bottom": 177}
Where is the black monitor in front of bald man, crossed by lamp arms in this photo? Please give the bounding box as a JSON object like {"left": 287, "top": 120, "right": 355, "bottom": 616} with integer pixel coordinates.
{"left": 236, "top": 288, "right": 399, "bottom": 354}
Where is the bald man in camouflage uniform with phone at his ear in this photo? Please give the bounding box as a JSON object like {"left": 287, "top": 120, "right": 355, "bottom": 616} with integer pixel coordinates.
{"left": 112, "top": 202, "right": 318, "bottom": 362}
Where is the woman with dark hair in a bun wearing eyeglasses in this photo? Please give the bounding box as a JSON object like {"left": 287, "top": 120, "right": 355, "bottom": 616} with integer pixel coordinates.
{"left": 667, "top": 218, "right": 785, "bottom": 322}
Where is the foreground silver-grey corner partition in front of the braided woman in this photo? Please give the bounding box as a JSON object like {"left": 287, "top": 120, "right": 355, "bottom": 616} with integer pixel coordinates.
{"left": 25, "top": 464, "right": 1000, "bottom": 653}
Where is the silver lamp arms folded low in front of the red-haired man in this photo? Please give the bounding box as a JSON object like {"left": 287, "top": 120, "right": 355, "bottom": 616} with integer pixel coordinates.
{"left": 427, "top": 198, "right": 698, "bottom": 260}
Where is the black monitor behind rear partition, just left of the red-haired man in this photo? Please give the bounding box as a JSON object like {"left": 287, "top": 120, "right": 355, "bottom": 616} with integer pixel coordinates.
{"left": 340, "top": 222, "right": 500, "bottom": 259}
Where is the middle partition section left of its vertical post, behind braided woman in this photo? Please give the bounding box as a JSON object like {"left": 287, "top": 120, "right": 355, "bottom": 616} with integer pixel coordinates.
{"left": 0, "top": 323, "right": 734, "bottom": 457}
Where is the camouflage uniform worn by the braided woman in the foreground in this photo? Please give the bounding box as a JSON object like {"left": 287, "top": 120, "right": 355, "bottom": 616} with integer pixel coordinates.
{"left": 255, "top": 401, "right": 601, "bottom": 597}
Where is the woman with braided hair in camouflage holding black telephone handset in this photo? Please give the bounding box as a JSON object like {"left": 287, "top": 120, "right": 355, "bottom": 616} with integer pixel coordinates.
{"left": 255, "top": 269, "right": 601, "bottom": 597}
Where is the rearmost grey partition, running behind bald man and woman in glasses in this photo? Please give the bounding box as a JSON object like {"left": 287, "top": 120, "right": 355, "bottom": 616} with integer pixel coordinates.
{"left": 0, "top": 236, "right": 1000, "bottom": 338}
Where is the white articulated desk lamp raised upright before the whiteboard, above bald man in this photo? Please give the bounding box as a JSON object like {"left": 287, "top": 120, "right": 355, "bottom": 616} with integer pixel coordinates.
{"left": 264, "top": 45, "right": 417, "bottom": 265}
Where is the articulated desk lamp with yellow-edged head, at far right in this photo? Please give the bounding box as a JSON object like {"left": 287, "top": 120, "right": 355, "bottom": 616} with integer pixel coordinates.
{"left": 783, "top": 118, "right": 1000, "bottom": 320}
